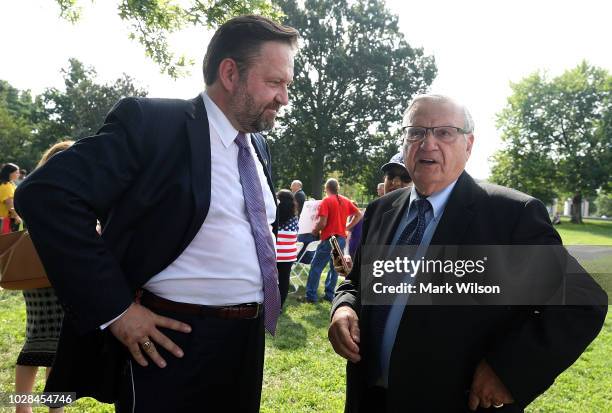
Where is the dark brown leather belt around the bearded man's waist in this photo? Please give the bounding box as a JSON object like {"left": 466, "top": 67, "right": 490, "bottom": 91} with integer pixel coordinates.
{"left": 140, "top": 290, "right": 263, "bottom": 320}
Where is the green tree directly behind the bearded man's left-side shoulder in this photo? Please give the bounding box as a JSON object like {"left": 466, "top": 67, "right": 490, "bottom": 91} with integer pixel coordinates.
{"left": 36, "top": 59, "right": 147, "bottom": 152}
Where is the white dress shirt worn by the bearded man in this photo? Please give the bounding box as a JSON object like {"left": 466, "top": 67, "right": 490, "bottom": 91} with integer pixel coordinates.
{"left": 144, "top": 92, "right": 276, "bottom": 305}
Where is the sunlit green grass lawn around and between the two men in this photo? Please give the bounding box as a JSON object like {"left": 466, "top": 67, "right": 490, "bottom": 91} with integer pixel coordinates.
{"left": 0, "top": 220, "right": 612, "bottom": 413}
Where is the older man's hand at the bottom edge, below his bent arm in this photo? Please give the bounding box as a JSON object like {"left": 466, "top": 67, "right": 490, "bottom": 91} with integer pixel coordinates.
{"left": 468, "top": 360, "right": 514, "bottom": 411}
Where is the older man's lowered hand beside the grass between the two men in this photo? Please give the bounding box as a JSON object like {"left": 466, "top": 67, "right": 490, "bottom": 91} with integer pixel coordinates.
{"left": 327, "top": 306, "right": 361, "bottom": 363}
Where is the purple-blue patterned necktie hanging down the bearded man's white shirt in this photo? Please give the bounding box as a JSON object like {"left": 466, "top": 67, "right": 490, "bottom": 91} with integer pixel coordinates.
{"left": 235, "top": 132, "right": 280, "bottom": 335}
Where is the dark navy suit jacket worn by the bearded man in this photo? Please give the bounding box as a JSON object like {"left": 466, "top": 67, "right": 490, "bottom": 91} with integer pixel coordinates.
{"left": 15, "top": 96, "right": 274, "bottom": 402}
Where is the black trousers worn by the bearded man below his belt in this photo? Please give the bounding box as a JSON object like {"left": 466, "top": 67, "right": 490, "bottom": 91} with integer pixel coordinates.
{"left": 115, "top": 302, "right": 265, "bottom": 413}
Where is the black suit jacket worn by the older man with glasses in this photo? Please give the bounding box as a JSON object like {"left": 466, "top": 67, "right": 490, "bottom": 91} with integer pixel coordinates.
{"left": 332, "top": 172, "right": 607, "bottom": 413}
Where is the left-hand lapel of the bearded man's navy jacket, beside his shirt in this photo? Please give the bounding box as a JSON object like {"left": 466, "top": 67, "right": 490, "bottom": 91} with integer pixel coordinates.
{"left": 180, "top": 95, "right": 211, "bottom": 246}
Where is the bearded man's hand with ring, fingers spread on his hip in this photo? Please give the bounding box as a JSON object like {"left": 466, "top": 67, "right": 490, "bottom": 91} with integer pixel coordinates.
{"left": 109, "top": 303, "right": 191, "bottom": 367}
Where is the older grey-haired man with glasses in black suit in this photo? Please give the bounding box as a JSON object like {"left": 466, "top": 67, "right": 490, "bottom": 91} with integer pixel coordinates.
{"left": 329, "top": 95, "right": 607, "bottom": 412}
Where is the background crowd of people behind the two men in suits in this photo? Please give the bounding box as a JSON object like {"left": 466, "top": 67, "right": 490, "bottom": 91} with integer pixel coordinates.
{"left": 0, "top": 140, "right": 411, "bottom": 413}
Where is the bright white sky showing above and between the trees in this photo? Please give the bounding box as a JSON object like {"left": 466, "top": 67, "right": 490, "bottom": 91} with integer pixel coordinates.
{"left": 0, "top": 0, "right": 612, "bottom": 178}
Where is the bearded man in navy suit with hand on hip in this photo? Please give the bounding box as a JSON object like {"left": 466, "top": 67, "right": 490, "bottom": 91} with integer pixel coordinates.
{"left": 16, "top": 16, "right": 298, "bottom": 413}
